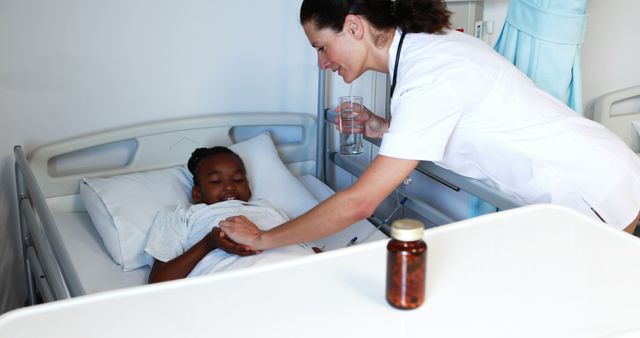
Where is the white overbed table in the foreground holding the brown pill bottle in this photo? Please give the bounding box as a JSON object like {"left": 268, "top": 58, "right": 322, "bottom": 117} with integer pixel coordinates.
{"left": 0, "top": 205, "right": 640, "bottom": 338}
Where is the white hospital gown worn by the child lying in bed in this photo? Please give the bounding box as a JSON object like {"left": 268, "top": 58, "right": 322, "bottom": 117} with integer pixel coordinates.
{"left": 145, "top": 199, "right": 313, "bottom": 276}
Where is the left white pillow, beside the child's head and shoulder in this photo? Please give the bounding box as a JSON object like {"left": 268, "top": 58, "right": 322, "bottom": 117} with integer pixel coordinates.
{"left": 80, "top": 166, "right": 192, "bottom": 271}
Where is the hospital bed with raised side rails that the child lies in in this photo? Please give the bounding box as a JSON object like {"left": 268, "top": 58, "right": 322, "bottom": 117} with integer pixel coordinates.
{"left": 14, "top": 72, "right": 521, "bottom": 304}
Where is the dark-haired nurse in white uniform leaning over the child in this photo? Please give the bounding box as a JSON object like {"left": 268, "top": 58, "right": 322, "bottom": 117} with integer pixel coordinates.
{"left": 221, "top": 0, "right": 640, "bottom": 249}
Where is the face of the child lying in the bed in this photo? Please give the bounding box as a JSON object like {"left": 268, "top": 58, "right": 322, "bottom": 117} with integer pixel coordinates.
{"left": 191, "top": 153, "right": 251, "bottom": 204}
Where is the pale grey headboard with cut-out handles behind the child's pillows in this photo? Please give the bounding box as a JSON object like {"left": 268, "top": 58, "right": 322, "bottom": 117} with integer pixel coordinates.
{"left": 28, "top": 113, "right": 317, "bottom": 209}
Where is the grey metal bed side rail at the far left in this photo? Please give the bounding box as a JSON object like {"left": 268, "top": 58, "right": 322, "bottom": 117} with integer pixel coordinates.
{"left": 14, "top": 145, "right": 85, "bottom": 304}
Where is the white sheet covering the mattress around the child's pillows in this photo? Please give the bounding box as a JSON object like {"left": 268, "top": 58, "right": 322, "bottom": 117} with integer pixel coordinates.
{"left": 53, "top": 175, "right": 387, "bottom": 294}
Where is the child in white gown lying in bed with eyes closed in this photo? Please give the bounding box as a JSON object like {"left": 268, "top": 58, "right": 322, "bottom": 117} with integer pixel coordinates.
{"left": 145, "top": 147, "right": 313, "bottom": 283}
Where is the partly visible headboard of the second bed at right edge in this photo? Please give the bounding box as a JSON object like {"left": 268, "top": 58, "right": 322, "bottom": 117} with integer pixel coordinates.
{"left": 593, "top": 86, "right": 640, "bottom": 152}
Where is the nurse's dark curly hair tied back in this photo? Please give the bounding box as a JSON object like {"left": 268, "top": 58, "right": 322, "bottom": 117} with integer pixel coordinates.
{"left": 300, "top": 0, "right": 451, "bottom": 34}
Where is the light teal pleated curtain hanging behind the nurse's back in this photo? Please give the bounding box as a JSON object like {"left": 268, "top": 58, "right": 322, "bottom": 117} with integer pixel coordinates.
{"left": 495, "top": 0, "right": 589, "bottom": 113}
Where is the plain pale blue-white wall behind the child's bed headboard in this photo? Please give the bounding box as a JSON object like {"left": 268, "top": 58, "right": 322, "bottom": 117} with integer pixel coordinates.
{"left": 0, "top": 0, "right": 317, "bottom": 313}
